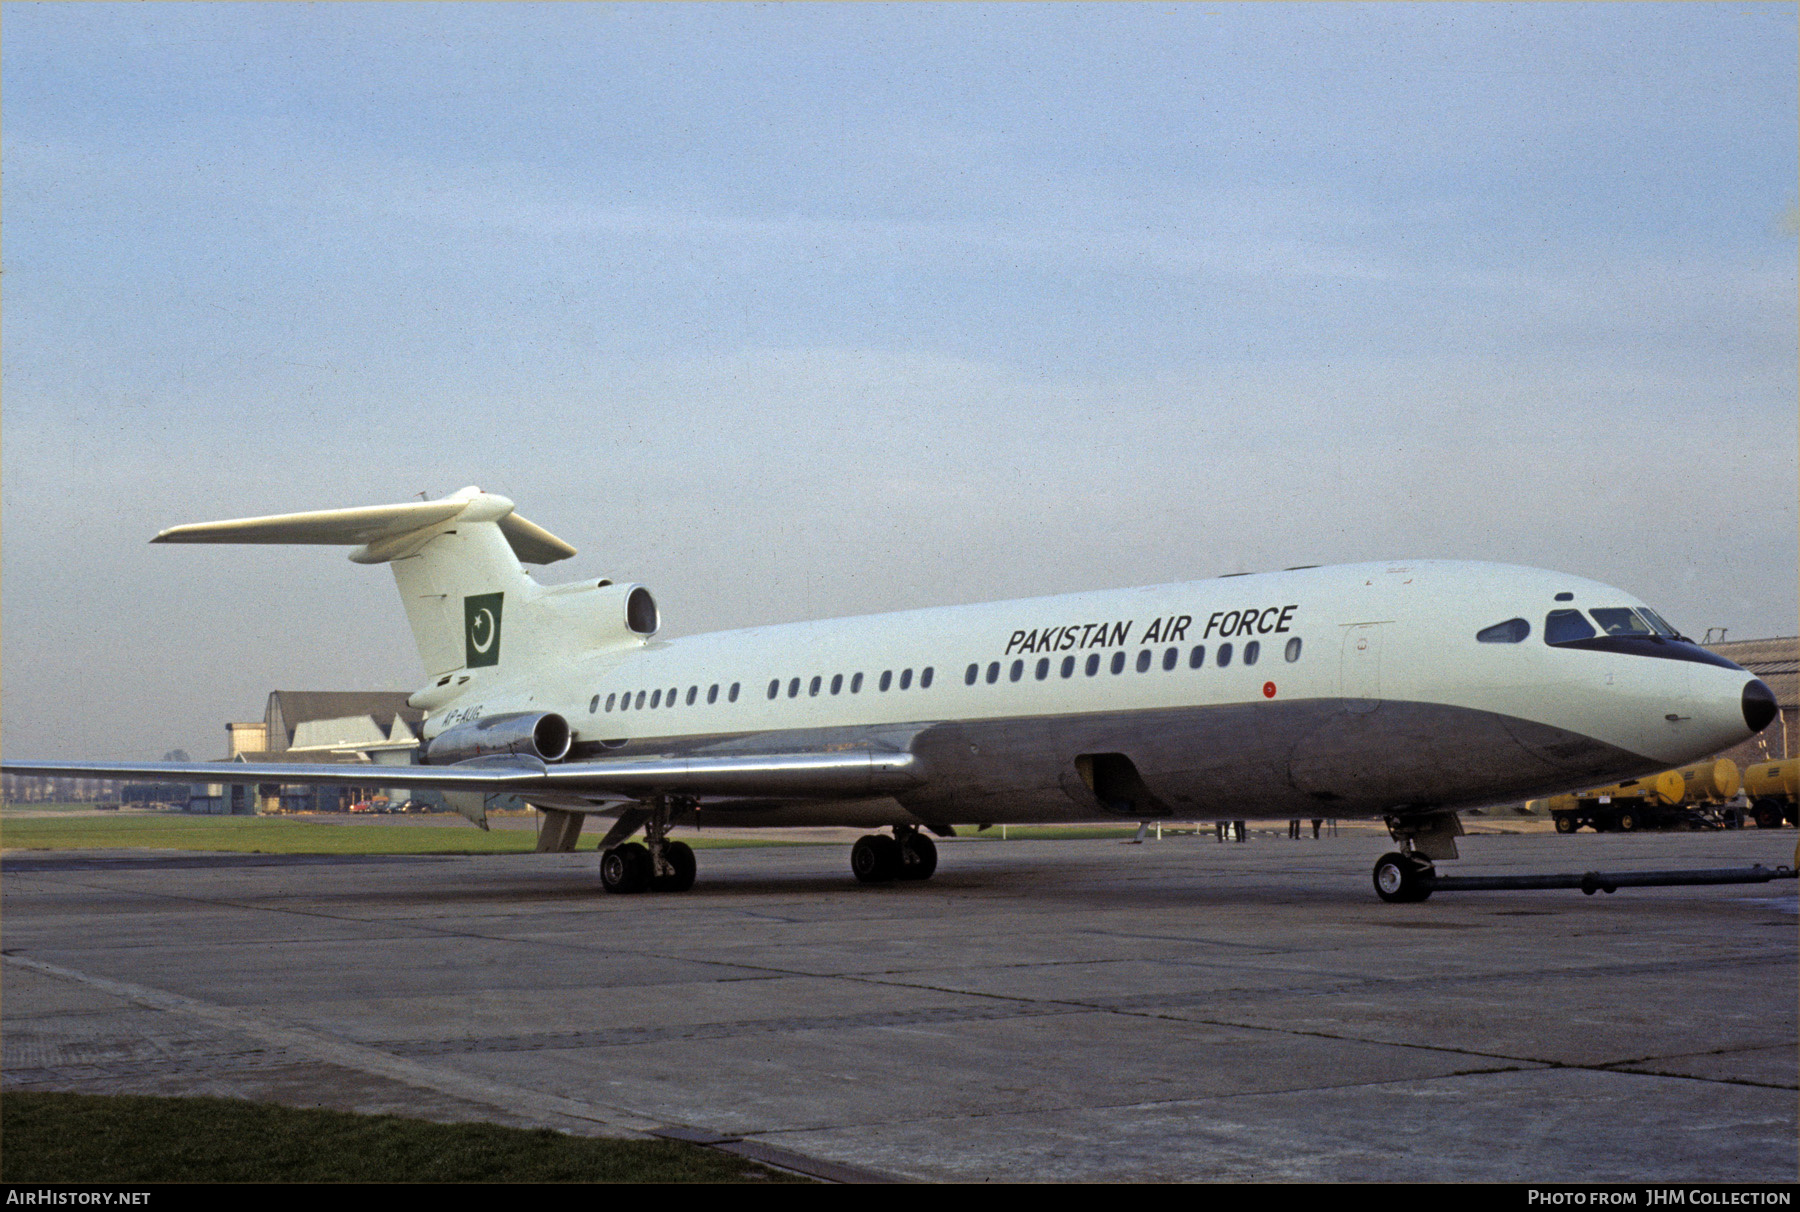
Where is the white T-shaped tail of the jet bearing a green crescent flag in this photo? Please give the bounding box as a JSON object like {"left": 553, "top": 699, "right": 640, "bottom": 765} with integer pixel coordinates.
{"left": 151, "top": 488, "right": 574, "bottom": 677}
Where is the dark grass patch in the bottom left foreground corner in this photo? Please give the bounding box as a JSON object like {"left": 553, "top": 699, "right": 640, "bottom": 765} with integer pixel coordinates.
{"left": 0, "top": 1091, "right": 808, "bottom": 1183}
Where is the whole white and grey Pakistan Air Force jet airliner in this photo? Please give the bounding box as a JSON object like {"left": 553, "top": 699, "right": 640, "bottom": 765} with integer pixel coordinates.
{"left": 17, "top": 488, "right": 1777, "bottom": 900}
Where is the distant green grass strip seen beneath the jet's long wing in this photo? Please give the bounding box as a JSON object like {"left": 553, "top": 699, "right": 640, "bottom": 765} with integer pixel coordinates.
{"left": 0, "top": 812, "right": 797, "bottom": 854}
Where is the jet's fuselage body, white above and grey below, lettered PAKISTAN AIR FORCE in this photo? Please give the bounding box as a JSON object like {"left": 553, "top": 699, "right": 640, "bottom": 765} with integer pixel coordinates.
{"left": 427, "top": 560, "right": 1750, "bottom": 823}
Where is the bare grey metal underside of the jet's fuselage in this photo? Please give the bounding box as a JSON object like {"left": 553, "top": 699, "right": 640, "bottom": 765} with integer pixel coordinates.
{"left": 554, "top": 699, "right": 1661, "bottom": 827}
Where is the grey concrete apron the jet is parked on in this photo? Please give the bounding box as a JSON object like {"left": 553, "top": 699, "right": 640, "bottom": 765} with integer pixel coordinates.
{"left": 0, "top": 830, "right": 1800, "bottom": 1183}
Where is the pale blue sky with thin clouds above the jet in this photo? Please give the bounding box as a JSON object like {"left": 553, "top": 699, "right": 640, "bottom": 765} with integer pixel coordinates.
{"left": 0, "top": 4, "right": 1800, "bottom": 760}
